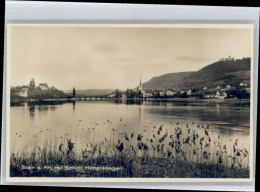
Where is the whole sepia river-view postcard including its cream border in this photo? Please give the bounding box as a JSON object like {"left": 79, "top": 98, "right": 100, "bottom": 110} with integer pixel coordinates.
{"left": 6, "top": 24, "right": 254, "bottom": 182}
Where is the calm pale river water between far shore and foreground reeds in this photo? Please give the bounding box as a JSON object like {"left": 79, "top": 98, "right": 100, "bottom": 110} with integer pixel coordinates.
{"left": 10, "top": 101, "right": 250, "bottom": 167}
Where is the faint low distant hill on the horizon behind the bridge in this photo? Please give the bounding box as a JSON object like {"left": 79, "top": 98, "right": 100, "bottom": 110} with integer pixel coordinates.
{"left": 64, "top": 89, "right": 115, "bottom": 97}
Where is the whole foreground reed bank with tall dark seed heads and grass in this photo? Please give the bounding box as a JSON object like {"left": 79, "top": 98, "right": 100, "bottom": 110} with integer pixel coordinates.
{"left": 10, "top": 119, "right": 249, "bottom": 178}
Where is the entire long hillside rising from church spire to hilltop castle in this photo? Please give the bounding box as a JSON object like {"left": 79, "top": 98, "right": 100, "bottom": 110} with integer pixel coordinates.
{"left": 143, "top": 58, "right": 250, "bottom": 90}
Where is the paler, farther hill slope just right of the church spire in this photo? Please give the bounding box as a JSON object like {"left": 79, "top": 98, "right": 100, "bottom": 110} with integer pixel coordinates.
{"left": 143, "top": 72, "right": 193, "bottom": 89}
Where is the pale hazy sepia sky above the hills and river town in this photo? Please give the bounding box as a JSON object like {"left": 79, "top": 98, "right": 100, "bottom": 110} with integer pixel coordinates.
{"left": 8, "top": 25, "right": 251, "bottom": 90}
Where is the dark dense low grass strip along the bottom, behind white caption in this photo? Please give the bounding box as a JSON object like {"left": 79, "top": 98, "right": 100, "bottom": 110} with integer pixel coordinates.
{"left": 10, "top": 154, "right": 249, "bottom": 178}
